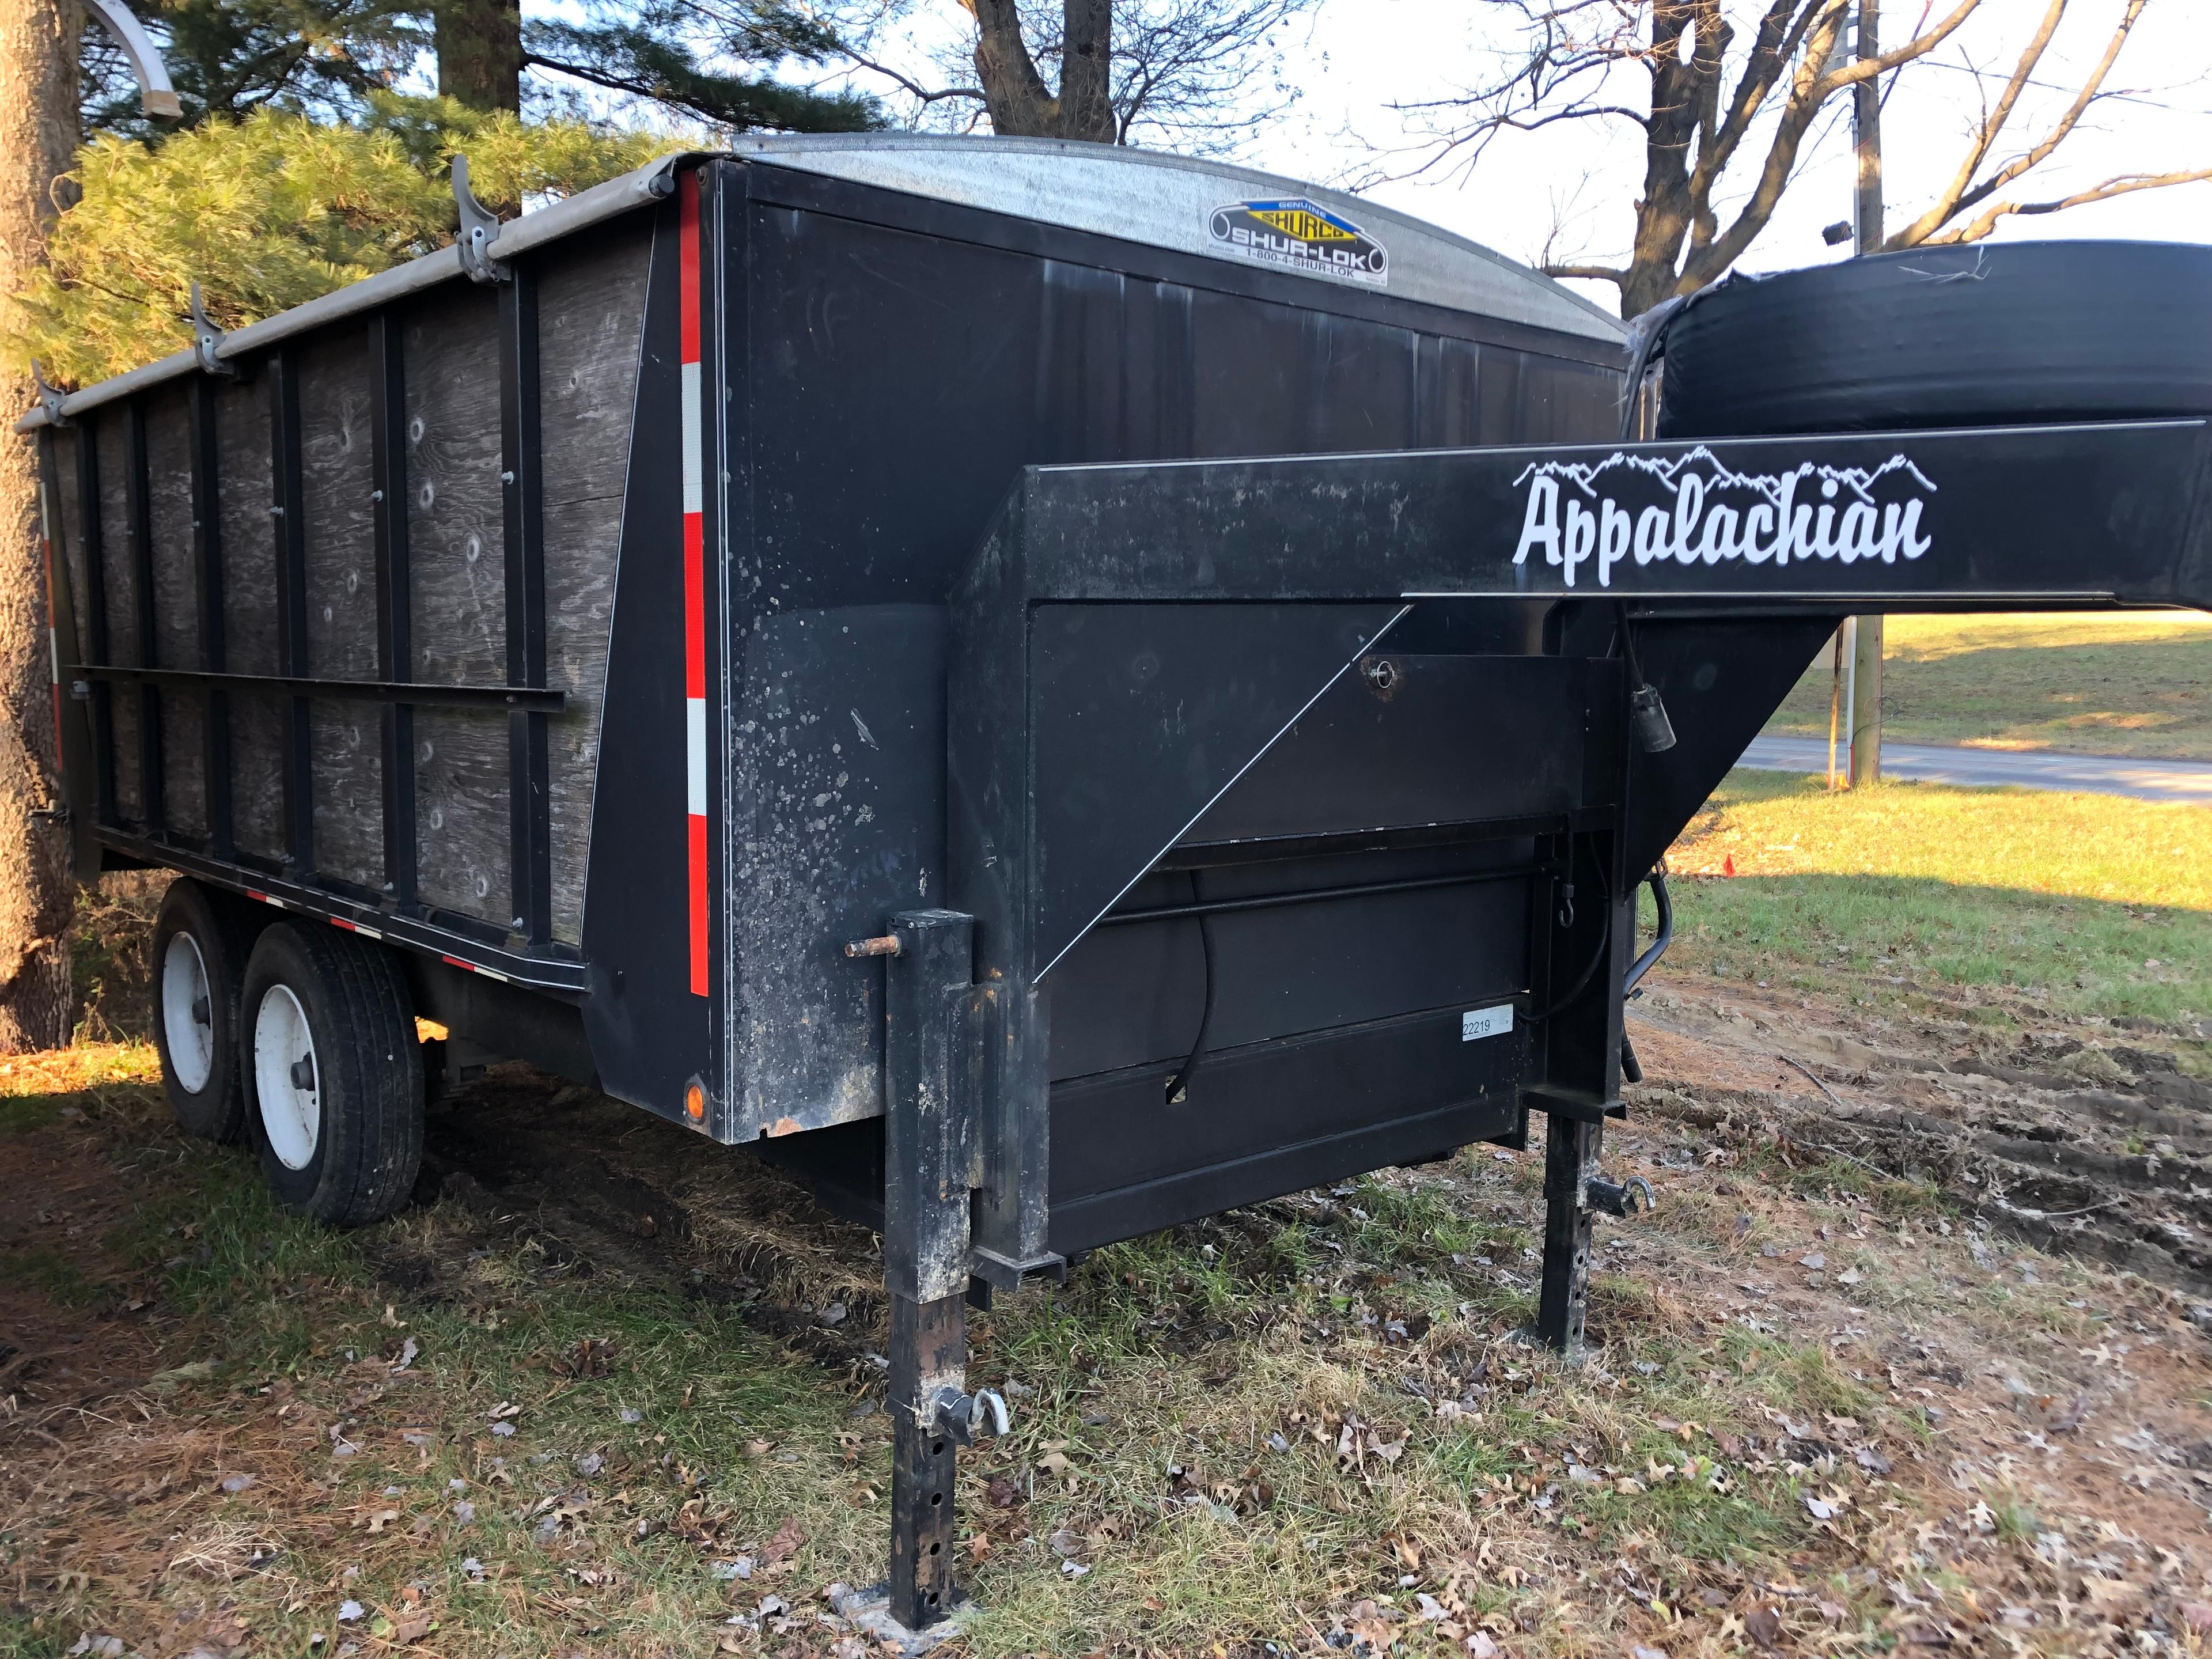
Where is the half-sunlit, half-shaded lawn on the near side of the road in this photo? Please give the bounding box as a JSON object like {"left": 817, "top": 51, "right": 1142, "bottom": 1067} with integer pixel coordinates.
{"left": 1646, "top": 770, "right": 2212, "bottom": 1022}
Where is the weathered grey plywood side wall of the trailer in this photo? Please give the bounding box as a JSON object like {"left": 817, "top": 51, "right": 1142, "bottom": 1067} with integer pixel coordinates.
{"left": 55, "top": 214, "right": 653, "bottom": 945}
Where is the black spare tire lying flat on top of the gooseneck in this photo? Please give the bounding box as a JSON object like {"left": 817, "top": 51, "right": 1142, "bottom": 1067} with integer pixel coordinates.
{"left": 1659, "top": 241, "right": 2212, "bottom": 438}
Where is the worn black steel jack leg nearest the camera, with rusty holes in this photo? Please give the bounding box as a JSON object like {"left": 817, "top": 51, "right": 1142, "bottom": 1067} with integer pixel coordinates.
{"left": 882, "top": 909, "right": 975, "bottom": 1630}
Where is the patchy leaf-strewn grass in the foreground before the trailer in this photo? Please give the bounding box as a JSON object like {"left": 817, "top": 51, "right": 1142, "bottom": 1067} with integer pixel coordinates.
{"left": 0, "top": 1066, "right": 1920, "bottom": 1657}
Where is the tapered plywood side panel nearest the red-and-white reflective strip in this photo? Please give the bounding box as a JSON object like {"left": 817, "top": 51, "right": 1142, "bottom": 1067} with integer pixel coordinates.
{"left": 537, "top": 221, "right": 653, "bottom": 945}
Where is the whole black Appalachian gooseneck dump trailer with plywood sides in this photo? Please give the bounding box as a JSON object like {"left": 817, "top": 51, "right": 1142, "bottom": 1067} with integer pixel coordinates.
{"left": 20, "top": 135, "right": 2212, "bottom": 1628}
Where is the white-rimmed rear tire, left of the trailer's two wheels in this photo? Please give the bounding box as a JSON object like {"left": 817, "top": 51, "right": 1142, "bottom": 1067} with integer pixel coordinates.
{"left": 153, "top": 876, "right": 259, "bottom": 1146}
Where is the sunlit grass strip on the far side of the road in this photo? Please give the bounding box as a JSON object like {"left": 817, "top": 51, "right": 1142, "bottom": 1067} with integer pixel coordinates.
{"left": 1767, "top": 611, "right": 2212, "bottom": 761}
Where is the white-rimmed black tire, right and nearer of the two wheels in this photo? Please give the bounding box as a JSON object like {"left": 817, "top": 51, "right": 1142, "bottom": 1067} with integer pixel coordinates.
{"left": 239, "top": 922, "right": 422, "bottom": 1228}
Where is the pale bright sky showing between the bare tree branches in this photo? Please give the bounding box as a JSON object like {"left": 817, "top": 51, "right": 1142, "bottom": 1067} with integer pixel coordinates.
{"left": 529, "top": 0, "right": 2212, "bottom": 310}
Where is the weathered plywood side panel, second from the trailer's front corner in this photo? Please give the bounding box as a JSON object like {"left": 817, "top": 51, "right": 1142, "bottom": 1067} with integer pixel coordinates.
{"left": 403, "top": 287, "right": 513, "bottom": 927}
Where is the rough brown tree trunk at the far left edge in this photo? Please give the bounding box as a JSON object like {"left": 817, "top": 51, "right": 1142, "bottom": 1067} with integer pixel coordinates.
{"left": 0, "top": 0, "right": 82, "bottom": 1053}
